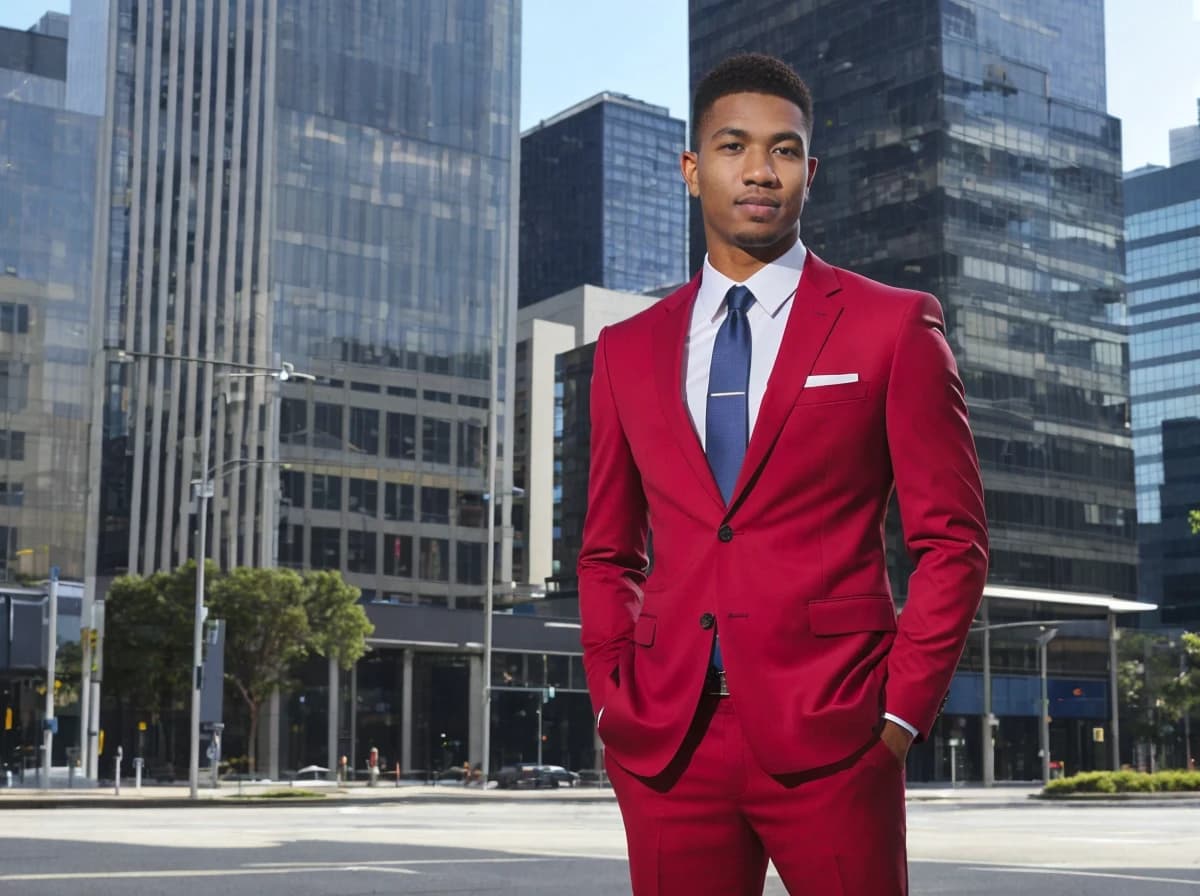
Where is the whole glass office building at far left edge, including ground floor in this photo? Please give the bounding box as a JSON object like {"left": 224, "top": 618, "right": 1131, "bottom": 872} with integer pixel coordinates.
{"left": 0, "top": 17, "right": 98, "bottom": 781}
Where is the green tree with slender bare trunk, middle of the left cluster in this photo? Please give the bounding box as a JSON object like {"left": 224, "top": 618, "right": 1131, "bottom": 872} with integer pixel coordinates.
{"left": 210, "top": 566, "right": 312, "bottom": 770}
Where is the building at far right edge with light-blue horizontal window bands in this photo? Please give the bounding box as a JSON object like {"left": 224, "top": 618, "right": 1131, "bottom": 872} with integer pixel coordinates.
{"left": 1124, "top": 157, "right": 1200, "bottom": 626}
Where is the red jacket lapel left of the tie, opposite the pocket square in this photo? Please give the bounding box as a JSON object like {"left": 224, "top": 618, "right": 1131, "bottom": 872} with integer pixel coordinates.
{"left": 652, "top": 273, "right": 725, "bottom": 512}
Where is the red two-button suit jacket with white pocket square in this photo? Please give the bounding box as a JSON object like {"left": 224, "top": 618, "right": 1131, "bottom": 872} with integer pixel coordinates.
{"left": 578, "top": 252, "right": 988, "bottom": 776}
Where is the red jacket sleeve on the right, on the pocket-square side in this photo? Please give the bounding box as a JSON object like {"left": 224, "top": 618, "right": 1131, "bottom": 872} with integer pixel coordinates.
{"left": 887, "top": 294, "right": 988, "bottom": 736}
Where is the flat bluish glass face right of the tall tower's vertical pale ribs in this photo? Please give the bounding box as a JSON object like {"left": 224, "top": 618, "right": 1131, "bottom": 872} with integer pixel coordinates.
{"left": 270, "top": 0, "right": 518, "bottom": 608}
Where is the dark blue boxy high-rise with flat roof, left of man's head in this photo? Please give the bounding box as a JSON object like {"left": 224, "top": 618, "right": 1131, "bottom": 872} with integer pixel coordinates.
{"left": 518, "top": 94, "right": 688, "bottom": 307}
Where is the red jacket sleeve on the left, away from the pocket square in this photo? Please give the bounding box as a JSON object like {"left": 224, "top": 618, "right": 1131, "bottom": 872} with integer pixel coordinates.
{"left": 577, "top": 330, "right": 649, "bottom": 714}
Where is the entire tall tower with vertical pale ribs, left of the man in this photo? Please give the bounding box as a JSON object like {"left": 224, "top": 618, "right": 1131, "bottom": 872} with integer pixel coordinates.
{"left": 67, "top": 0, "right": 592, "bottom": 771}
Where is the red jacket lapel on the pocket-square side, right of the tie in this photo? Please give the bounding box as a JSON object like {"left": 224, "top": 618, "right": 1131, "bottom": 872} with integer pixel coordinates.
{"left": 724, "top": 251, "right": 842, "bottom": 516}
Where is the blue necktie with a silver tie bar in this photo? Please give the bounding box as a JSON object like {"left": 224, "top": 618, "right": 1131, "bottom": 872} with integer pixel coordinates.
{"left": 704, "top": 287, "right": 754, "bottom": 669}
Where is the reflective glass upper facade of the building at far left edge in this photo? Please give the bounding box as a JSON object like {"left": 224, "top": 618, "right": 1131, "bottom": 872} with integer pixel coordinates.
{"left": 0, "top": 29, "right": 98, "bottom": 582}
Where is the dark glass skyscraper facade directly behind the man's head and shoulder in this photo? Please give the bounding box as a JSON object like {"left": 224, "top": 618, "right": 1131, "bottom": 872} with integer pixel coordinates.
{"left": 690, "top": 0, "right": 1136, "bottom": 596}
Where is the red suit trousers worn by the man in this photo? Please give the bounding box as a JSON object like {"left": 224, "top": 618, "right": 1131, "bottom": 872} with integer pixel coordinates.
{"left": 605, "top": 696, "right": 908, "bottom": 896}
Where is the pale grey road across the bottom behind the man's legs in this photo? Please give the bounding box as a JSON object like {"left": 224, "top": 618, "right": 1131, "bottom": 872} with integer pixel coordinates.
{"left": 0, "top": 800, "right": 1200, "bottom": 896}
